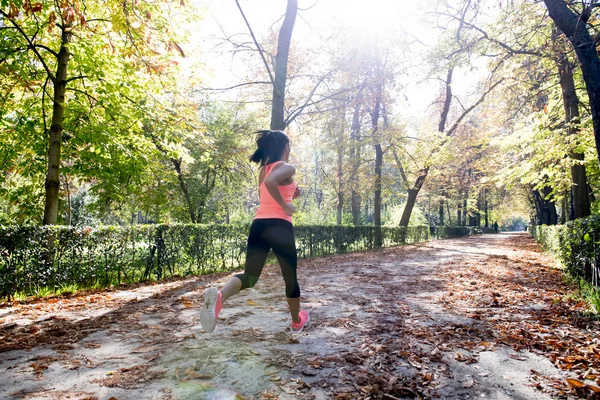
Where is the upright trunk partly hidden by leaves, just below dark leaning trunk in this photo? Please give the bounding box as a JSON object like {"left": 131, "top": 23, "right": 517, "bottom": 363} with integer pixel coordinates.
{"left": 553, "top": 35, "right": 591, "bottom": 218}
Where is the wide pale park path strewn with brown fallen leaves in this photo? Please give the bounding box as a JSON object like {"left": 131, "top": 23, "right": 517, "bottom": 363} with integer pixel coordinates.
{"left": 0, "top": 233, "right": 600, "bottom": 400}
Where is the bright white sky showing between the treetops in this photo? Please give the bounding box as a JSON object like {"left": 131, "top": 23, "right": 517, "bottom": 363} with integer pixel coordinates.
{"left": 188, "top": 0, "right": 496, "bottom": 126}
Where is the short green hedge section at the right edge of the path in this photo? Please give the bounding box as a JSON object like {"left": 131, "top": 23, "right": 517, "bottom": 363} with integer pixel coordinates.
{"left": 530, "top": 215, "right": 600, "bottom": 288}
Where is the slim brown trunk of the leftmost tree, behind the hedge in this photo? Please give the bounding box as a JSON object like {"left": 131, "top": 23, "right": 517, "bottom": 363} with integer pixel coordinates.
{"left": 43, "top": 25, "right": 72, "bottom": 225}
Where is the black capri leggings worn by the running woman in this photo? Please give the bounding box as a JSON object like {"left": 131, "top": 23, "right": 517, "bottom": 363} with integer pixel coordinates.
{"left": 235, "top": 218, "right": 300, "bottom": 298}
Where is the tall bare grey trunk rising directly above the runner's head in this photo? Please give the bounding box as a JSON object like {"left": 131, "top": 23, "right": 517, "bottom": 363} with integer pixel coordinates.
{"left": 271, "top": 0, "right": 298, "bottom": 130}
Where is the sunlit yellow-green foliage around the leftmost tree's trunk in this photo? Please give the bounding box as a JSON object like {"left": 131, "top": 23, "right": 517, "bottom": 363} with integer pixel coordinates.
{"left": 0, "top": 0, "right": 201, "bottom": 224}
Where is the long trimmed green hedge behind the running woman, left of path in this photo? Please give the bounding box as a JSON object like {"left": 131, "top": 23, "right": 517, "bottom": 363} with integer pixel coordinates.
{"left": 0, "top": 224, "right": 473, "bottom": 299}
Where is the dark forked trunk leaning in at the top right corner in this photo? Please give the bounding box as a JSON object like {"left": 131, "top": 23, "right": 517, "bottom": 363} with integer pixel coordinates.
{"left": 544, "top": 0, "right": 600, "bottom": 170}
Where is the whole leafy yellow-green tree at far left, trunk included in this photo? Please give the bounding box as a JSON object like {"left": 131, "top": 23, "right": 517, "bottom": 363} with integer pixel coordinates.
{"left": 0, "top": 1, "right": 189, "bottom": 224}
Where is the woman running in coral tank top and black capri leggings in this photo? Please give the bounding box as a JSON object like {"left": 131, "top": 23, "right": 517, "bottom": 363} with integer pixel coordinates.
{"left": 200, "top": 130, "right": 310, "bottom": 333}
